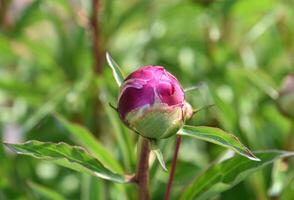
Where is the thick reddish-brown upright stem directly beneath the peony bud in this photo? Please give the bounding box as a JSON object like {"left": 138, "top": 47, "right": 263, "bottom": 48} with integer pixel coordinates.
{"left": 136, "top": 137, "right": 150, "bottom": 200}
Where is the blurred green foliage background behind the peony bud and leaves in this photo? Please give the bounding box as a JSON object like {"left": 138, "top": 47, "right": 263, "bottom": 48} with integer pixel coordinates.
{"left": 0, "top": 0, "right": 294, "bottom": 200}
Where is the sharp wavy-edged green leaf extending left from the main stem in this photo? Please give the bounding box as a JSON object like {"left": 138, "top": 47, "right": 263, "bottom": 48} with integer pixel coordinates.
{"left": 4, "top": 140, "right": 128, "bottom": 183}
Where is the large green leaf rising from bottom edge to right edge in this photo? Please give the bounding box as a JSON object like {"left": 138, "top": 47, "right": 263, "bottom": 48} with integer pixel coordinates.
{"left": 181, "top": 151, "right": 294, "bottom": 200}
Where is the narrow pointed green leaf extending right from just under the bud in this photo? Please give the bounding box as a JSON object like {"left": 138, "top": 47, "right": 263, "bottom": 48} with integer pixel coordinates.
{"left": 177, "top": 125, "right": 260, "bottom": 161}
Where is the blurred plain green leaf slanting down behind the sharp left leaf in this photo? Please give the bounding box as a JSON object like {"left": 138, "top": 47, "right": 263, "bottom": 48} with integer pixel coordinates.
{"left": 56, "top": 115, "right": 123, "bottom": 173}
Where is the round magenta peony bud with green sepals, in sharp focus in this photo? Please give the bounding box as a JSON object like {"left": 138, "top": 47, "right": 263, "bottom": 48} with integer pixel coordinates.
{"left": 118, "top": 66, "right": 192, "bottom": 139}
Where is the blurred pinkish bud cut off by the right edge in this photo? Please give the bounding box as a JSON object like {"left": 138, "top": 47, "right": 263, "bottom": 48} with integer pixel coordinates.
{"left": 278, "top": 74, "right": 294, "bottom": 118}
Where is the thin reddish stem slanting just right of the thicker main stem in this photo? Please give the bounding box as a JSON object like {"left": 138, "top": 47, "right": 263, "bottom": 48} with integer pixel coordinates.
{"left": 164, "top": 135, "right": 182, "bottom": 200}
